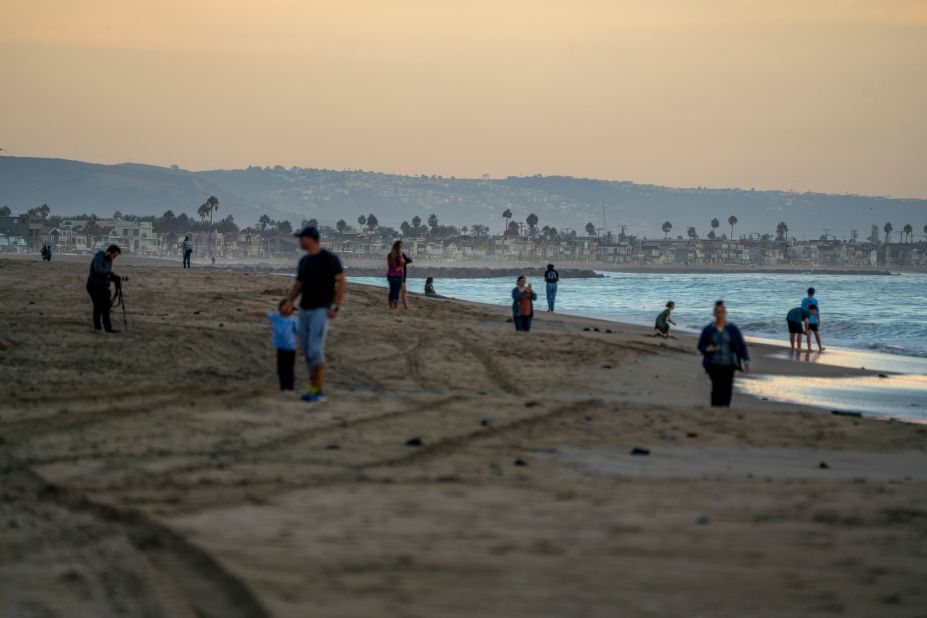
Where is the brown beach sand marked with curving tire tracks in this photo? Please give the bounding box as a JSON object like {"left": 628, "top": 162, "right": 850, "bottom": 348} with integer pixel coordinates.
{"left": 0, "top": 253, "right": 927, "bottom": 617}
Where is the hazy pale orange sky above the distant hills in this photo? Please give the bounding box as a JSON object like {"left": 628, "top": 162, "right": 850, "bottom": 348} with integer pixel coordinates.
{"left": 0, "top": 0, "right": 927, "bottom": 197}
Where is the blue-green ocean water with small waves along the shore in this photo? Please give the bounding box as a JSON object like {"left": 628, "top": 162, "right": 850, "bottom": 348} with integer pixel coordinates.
{"left": 353, "top": 273, "right": 927, "bottom": 357}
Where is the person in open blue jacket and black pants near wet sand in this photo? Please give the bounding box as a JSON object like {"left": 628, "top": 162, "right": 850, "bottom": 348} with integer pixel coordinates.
{"left": 698, "top": 300, "right": 750, "bottom": 407}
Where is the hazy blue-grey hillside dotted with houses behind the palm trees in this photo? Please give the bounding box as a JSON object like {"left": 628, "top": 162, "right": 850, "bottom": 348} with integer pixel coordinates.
{"left": 0, "top": 157, "right": 927, "bottom": 238}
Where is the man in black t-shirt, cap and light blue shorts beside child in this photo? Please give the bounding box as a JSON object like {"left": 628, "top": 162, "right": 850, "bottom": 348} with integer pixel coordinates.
{"left": 283, "top": 225, "right": 347, "bottom": 401}
